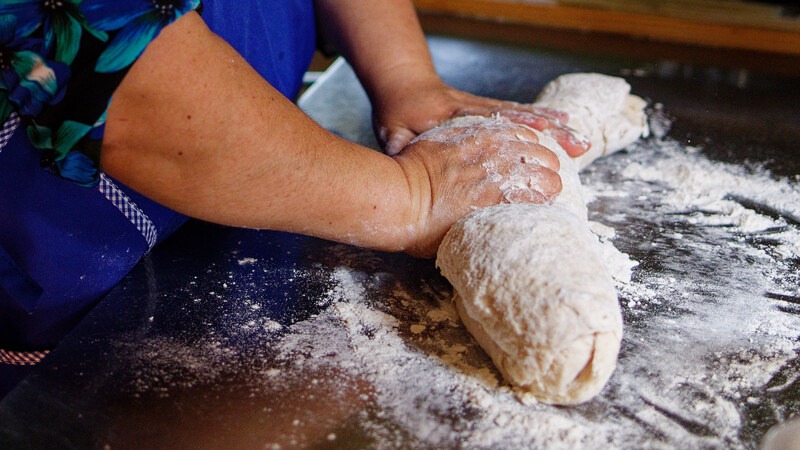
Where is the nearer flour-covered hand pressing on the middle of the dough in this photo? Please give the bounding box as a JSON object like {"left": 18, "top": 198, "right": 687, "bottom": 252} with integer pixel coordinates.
{"left": 395, "top": 117, "right": 561, "bottom": 257}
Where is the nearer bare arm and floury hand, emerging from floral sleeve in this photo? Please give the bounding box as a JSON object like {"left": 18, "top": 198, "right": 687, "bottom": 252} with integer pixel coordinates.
{"left": 101, "top": 12, "right": 560, "bottom": 256}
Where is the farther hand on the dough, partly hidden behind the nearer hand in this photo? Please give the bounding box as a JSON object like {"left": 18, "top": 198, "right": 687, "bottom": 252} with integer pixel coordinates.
{"left": 373, "top": 75, "right": 590, "bottom": 157}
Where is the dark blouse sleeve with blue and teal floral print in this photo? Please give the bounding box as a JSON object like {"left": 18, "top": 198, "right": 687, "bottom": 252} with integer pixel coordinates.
{"left": 0, "top": 0, "right": 200, "bottom": 186}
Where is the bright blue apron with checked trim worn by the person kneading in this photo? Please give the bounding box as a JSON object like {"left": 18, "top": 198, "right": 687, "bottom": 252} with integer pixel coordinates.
{"left": 0, "top": 0, "right": 316, "bottom": 390}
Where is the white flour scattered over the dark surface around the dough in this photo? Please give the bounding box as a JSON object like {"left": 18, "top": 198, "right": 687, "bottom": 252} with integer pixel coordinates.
{"left": 115, "top": 108, "right": 800, "bottom": 449}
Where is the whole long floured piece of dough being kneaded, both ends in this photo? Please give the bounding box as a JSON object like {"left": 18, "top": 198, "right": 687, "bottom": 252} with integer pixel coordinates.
{"left": 436, "top": 74, "right": 647, "bottom": 404}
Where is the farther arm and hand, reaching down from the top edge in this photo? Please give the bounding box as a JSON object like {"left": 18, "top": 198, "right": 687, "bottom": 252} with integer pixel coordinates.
{"left": 315, "top": 0, "right": 589, "bottom": 156}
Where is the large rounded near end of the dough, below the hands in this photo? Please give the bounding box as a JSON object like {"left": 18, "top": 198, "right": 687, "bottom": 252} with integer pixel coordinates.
{"left": 437, "top": 204, "right": 622, "bottom": 404}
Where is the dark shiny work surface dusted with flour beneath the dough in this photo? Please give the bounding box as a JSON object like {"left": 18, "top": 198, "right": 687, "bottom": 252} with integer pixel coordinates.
{"left": 0, "top": 38, "right": 800, "bottom": 448}
